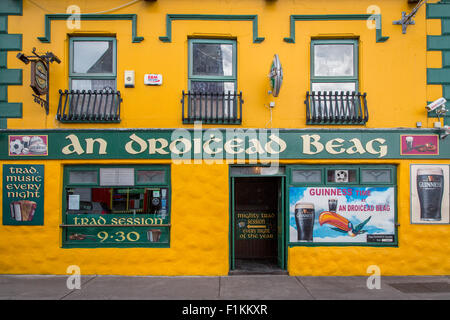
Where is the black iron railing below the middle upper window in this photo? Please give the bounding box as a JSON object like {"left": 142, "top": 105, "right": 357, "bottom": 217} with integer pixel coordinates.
{"left": 181, "top": 91, "right": 244, "bottom": 124}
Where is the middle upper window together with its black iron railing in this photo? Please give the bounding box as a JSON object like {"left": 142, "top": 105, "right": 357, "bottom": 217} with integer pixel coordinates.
{"left": 182, "top": 39, "right": 243, "bottom": 124}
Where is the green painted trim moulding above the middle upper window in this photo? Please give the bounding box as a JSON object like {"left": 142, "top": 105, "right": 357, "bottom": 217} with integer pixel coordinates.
{"left": 159, "top": 14, "right": 265, "bottom": 43}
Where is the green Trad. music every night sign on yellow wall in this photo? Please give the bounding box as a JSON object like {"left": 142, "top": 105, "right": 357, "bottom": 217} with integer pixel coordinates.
{"left": 2, "top": 164, "right": 44, "bottom": 225}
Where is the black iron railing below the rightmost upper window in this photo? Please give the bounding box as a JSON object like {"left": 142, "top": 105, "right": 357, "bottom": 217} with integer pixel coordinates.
{"left": 305, "top": 91, "right": 369, "bottom": 125}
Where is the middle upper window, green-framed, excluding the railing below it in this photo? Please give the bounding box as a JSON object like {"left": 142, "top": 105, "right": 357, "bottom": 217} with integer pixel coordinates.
{"left": 189, "top": 39, "right": 236, "bottom": 93}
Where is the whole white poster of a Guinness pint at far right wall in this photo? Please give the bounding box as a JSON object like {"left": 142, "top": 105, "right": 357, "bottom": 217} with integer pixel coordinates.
{"left": 410, "top": 164, "right": 450, "bottom": 224}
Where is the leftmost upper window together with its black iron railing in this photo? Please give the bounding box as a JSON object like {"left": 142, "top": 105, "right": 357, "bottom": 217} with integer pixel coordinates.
{"left": 56, "top": 37, "right": 122, "bottom": 123}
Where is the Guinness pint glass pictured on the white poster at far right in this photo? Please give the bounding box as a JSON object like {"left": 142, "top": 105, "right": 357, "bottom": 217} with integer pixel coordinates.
{"left": 417, "top": 167, "right": 444, "bottom": 221}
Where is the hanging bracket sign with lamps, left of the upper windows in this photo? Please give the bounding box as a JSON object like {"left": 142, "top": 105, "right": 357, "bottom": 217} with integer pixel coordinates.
{"left": 17, "top": 48, "right": 61, "bottom": 114}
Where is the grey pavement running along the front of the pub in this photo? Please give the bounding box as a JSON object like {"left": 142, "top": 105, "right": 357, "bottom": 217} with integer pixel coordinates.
{"left": 0, "top": 275, "right": 450, "bottom": 301}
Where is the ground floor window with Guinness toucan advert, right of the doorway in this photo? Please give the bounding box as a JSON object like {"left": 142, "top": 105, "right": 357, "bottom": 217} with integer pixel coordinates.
{"left": 288, "top": 165, "right": 398, "bottom": 246}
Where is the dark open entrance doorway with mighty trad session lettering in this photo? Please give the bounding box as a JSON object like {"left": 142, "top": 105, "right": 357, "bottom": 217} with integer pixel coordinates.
{"left": 232, "top": 176, "right": 285, "bottom": 274}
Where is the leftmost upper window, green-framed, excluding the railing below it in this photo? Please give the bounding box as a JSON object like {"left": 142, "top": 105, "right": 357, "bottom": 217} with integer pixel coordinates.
{"left": 69, "top": 37, "right": 117, "bottom": 91}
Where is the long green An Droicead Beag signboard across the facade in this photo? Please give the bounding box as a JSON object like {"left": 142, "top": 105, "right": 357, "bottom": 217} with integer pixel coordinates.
{"left": 0, "top": 126, "right": 450, "bottom": 161}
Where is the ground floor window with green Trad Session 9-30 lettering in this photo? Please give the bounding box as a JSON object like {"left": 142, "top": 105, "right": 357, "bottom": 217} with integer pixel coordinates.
{"left": 61, "top": 165, "right": 170, "bottom": 248}
